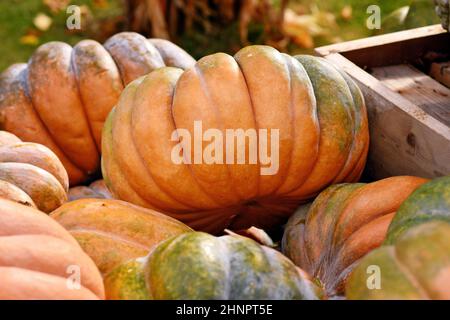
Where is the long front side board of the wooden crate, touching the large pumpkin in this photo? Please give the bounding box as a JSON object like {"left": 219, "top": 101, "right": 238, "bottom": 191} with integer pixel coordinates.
{"left": 325, "top": 53, "right": 450, "bottom": 179}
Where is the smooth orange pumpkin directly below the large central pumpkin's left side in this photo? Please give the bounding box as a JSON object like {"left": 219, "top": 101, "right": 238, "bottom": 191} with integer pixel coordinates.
{"left": 50, "top": 199, "right": 191, "bottom": 274}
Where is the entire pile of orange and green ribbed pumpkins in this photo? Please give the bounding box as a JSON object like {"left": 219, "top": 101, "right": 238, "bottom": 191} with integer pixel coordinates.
{"left": 0, "top": 32, "right": 450, "bottom": 299}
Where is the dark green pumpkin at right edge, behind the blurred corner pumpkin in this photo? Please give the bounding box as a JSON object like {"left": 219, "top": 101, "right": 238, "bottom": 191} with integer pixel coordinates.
{"left": 386, "top": 176, "right": 450, "bottom": 244}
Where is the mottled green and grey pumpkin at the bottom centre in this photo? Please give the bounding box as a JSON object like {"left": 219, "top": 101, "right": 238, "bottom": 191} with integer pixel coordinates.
{"left": 105, "top": 232, "right": 321, "bottom": 300}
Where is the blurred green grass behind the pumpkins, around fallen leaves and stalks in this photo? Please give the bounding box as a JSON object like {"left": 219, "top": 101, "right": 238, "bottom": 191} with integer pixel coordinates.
{"left": 0, "top": 0, "right": 442, "bottom": 72}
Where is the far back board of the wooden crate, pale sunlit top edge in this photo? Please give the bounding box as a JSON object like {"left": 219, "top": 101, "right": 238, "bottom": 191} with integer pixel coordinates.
{"left": 316, "top": 25, "right": 450, "bottom": 69}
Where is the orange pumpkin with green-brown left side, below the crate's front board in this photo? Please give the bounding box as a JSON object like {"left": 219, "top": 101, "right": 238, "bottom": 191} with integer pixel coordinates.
{"left": 282, "top": 176, "right": 427, "bottom": 296}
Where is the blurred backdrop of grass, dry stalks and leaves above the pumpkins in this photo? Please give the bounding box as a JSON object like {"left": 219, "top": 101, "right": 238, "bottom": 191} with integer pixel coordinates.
{"left": 0, "top": 0, "right": 439, "bottom": 72}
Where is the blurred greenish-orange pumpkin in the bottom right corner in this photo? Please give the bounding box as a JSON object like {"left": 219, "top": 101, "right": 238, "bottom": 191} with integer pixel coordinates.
{"left": 345, "top": 220, "right": 450, "bottom": 300}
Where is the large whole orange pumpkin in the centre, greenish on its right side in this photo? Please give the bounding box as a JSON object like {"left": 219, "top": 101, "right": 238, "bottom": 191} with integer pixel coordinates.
{"left": 102, "top": 46, "right": 368, "bottom": 233}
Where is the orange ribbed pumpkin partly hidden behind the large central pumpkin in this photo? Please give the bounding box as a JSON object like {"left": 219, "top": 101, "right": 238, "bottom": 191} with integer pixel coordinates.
{"left": 0, "top": 32, "right": 194, "bottom": 185}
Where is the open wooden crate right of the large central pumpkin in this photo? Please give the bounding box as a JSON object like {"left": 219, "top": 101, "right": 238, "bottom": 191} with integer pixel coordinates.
{"left": 316, "top": 25, "right": 450, "bottom": 179}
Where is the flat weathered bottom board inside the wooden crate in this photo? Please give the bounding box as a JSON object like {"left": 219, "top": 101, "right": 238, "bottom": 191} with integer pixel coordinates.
{"left": 371, "top": 64, "right": 450, "bottom": 126}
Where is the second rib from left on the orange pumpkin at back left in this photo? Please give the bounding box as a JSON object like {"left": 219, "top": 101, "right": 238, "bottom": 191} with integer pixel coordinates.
{"left": 27, "top": 42, "right": 99, "bottom": 174}
